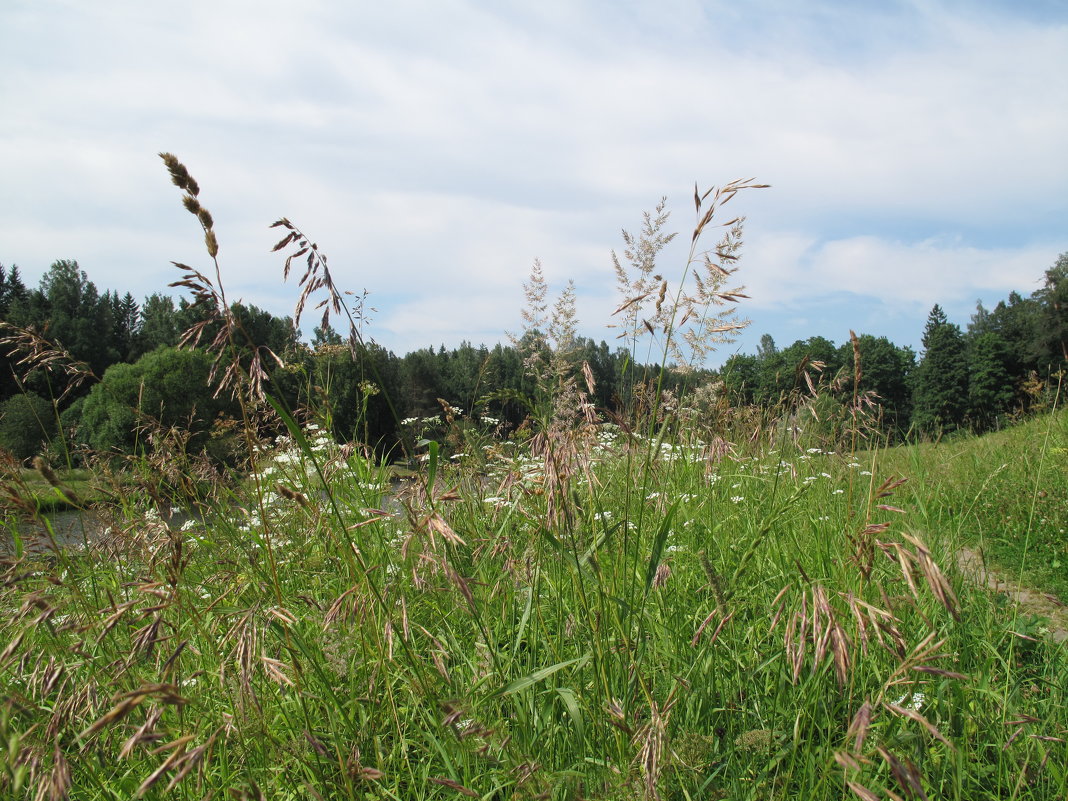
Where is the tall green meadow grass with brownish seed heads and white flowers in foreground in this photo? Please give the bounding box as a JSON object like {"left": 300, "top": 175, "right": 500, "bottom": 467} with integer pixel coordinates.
{"left": 0, "top": 160, "right": 1068, "bottom": 800}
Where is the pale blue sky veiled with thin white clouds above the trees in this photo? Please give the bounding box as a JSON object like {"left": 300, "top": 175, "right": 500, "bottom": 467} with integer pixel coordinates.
{"left": 0, "top": 0, "right": 1068, "bottom": 366}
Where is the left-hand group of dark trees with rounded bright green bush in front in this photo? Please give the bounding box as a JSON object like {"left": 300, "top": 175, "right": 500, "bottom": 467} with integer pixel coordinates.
{"left": 0, "top": 261, "right": 297, "bottom": 459}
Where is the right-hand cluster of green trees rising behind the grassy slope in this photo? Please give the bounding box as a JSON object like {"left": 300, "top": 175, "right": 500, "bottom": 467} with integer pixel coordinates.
{"left": 722, "top": 253, "right": 1068, "bottom": 438}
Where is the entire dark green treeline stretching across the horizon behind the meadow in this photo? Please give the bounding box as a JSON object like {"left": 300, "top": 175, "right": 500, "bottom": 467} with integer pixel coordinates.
{"left": 0, "top": 253, "right": 1068, "bottom": 461}
